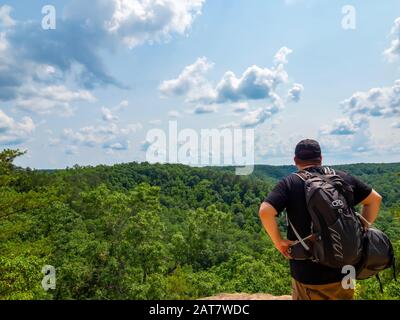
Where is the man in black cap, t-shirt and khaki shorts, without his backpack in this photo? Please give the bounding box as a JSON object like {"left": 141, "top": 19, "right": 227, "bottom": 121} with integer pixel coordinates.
{"left": 259, "top": 139, "right": 382, "bottom": 300}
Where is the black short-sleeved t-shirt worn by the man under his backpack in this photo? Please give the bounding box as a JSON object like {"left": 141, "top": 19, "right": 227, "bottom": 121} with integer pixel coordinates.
{"left": 264, "top": 167, "right": 372, "bottom": 285}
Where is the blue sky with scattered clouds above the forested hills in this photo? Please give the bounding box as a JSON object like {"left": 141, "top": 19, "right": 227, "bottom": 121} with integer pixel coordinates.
{"left": 0, "top": 0, "right": 400, "bottom": 168}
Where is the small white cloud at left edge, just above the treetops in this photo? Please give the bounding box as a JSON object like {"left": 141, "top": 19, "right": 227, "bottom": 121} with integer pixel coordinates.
{"left": 0, "top": 110, "right": 36, "bottom": 145}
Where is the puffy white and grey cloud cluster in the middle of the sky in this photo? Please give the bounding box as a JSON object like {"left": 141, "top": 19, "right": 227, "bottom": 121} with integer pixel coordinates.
{"left": 159, "top": 47, "right": 304, "bottom": 127}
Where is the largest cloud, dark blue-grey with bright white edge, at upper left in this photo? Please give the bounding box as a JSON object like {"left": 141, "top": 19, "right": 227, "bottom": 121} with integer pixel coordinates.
{"left": 0, "top": 0, "right": 204, "bottom": 117}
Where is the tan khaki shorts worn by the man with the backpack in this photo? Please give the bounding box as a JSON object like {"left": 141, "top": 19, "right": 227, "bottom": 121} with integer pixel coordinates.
{"left": 292, "top": 278, "right": 354, "bottom": 300}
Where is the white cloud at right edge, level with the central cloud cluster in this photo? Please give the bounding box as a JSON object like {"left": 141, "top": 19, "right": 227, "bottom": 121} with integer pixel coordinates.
{"left": 341, "top": 80, "right": 400, "bottom": 117}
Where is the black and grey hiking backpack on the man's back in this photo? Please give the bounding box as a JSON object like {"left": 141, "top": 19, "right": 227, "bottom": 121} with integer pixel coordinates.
{"left": 288, "top": 168, "right": 395, "bottom": 280}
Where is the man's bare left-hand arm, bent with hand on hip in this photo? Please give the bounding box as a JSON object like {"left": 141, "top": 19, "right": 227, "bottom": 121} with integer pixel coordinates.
{"left": 259, "top": 202, "right": 293, "bottom": 258}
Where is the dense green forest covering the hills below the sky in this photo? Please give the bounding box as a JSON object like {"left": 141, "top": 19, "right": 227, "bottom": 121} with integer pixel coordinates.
{"left": 0, "top": 149, "right": 400, "bottom": 300}
